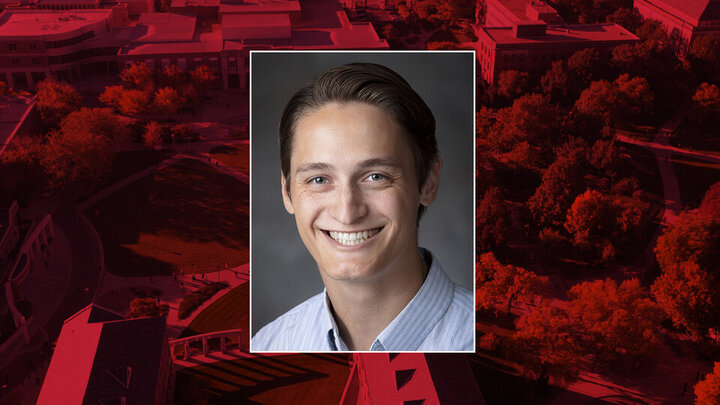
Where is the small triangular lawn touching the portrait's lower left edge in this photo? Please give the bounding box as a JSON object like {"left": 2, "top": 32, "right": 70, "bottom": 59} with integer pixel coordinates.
{"left": 180, "top": 283, "right": 250, "bottom": 344}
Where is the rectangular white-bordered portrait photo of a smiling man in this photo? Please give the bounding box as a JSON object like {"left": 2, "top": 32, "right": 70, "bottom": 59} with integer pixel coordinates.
{"left": 250, "top": 51, "right": 475, "bottom": 352}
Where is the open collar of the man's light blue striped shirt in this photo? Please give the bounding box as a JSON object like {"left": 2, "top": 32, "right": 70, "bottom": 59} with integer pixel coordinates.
{"left": 320, "top": 248, "right": 455, "bottom": 351}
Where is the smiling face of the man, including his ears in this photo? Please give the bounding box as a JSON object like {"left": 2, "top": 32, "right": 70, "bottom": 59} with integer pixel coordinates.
{"left": 283, "top": 103, "right": 440, "bottom": 284}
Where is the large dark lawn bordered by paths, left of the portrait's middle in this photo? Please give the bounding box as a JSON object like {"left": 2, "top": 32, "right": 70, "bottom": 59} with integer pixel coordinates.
{"left": 86, "top": 159, "right": 249, "bottom": 276}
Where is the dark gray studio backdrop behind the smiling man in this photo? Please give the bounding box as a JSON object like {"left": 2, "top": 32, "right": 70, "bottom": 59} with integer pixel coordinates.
{"left": 250, "top": 52, "right": 475, "bottom": 335}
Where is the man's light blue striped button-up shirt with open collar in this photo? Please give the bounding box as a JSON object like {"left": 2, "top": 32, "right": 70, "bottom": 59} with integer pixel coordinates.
{"left": 251, "top": 249, "right": 475, "bottom": 352}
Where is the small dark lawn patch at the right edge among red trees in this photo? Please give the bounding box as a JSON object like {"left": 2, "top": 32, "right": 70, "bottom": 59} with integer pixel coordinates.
{"left": 672, "top": 156, "right": 720, "bottom": 209}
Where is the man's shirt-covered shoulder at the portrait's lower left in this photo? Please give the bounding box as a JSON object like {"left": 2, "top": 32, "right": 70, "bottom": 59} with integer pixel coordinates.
{"left": 252, "top": 292, "right": 325, "bottom": 351}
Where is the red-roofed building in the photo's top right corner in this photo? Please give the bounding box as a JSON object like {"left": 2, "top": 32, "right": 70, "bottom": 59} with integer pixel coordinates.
{"left": 634, "top": 0, "right": 720, "bottom": 57}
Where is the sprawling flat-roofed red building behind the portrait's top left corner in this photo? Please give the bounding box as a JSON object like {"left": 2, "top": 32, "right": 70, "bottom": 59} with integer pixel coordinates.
{"left": 118, "top": 0, "right": 388, "bottom": 89}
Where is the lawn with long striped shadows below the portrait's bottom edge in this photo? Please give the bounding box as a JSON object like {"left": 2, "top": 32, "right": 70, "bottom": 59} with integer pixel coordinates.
{"left": 175, "top": 354, "right": 350, "bottom": 405}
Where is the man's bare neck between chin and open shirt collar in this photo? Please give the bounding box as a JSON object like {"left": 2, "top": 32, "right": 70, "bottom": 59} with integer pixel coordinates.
{"left": 325, "top": 251, "right": 428, "bottom": 350}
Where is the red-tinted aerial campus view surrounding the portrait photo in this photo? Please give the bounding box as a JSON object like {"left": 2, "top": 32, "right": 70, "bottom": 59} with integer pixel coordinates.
{"left": 0, "top": 0, "right": 720, "bottom": 404}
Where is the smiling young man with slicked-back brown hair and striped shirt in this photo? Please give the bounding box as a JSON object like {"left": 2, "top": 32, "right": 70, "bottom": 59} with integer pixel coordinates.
{"left": 253, "top": 63, "right": 474, "bottom": 351}
